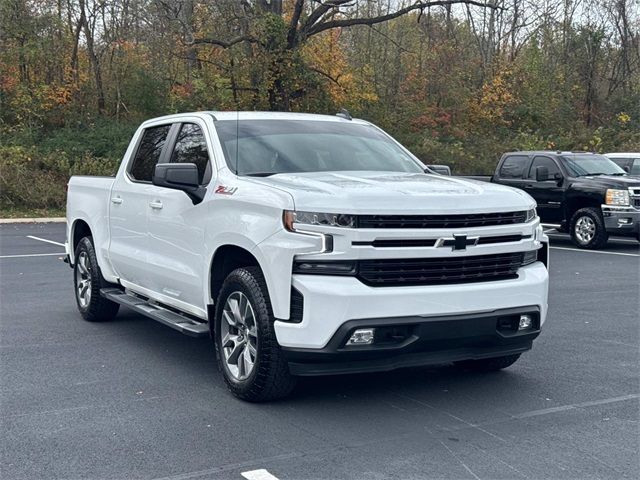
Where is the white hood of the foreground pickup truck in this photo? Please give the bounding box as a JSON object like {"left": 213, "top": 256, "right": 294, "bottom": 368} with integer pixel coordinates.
{"left": 251, "top": 171, "right": 535, "bottom": 215}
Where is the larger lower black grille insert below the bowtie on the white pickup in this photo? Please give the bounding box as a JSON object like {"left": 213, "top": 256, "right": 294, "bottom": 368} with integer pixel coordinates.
{"left": 358, "top": 252, "right": 524, "bottom": 287}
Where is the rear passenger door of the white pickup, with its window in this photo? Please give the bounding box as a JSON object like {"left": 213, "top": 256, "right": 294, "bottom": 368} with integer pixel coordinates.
{"left": 104, "top": 124, "right": 171, "bottom": 287}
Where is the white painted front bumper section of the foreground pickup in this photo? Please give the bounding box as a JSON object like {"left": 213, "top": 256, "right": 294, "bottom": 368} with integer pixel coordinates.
{"left": 274, "top": 262, "right": 549, "bottom": 350}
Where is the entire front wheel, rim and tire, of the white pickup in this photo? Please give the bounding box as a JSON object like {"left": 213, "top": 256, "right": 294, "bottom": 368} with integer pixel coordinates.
{"left": 214, "top": 267, "right": 295, "bottom": 402}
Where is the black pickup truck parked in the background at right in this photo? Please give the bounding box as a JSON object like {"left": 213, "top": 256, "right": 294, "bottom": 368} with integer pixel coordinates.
{"left": 491, "top": 151, "right": 640, "bottom": 248}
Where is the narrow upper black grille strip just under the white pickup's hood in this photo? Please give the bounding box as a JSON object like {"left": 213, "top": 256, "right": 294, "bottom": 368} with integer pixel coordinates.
{"left": 358, "top": 211, "right": 527, "bottom": 228}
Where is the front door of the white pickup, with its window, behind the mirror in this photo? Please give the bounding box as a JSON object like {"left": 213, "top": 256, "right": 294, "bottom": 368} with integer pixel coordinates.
{"left": 147, "top": 119, "right": 213, "bottom": 316}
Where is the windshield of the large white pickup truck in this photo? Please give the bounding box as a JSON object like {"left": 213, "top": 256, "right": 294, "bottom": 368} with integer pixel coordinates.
{"left": 215, "top": 120, "right": 423, "bottom": 176}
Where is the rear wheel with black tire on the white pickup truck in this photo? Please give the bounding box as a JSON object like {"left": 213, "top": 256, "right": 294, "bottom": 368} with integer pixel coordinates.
{"left": 73, "top": 237, "right": 120, "bottom": 322}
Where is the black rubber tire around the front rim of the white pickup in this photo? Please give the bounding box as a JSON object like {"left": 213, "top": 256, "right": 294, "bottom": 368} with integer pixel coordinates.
{"left": 214, "top": 267, "right": 296, "bottom": 402}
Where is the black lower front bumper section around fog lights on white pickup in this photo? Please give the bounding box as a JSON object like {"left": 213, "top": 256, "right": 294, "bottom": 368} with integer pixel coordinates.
{"left": 283, "top": 306, "right": 540, "bottom": 376}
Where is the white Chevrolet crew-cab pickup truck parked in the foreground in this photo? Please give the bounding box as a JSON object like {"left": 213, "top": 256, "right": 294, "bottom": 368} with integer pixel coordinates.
{"left": 66, "top": 112, "right": 548, "bottom": 401}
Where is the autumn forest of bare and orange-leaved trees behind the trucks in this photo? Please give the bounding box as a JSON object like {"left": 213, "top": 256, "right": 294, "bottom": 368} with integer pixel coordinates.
{"left": 0, "top": 0, "right": 640, "bottom": 217}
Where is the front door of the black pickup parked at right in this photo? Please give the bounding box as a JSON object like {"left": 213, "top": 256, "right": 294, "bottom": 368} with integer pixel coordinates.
{"left": 525, "top": 155, "right": 564, "bottom": 223}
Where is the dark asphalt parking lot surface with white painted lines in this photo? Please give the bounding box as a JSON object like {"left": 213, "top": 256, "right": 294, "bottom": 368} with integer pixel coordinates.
{"left": 0, "top": 224, "right": 640, "bottom": 480}
